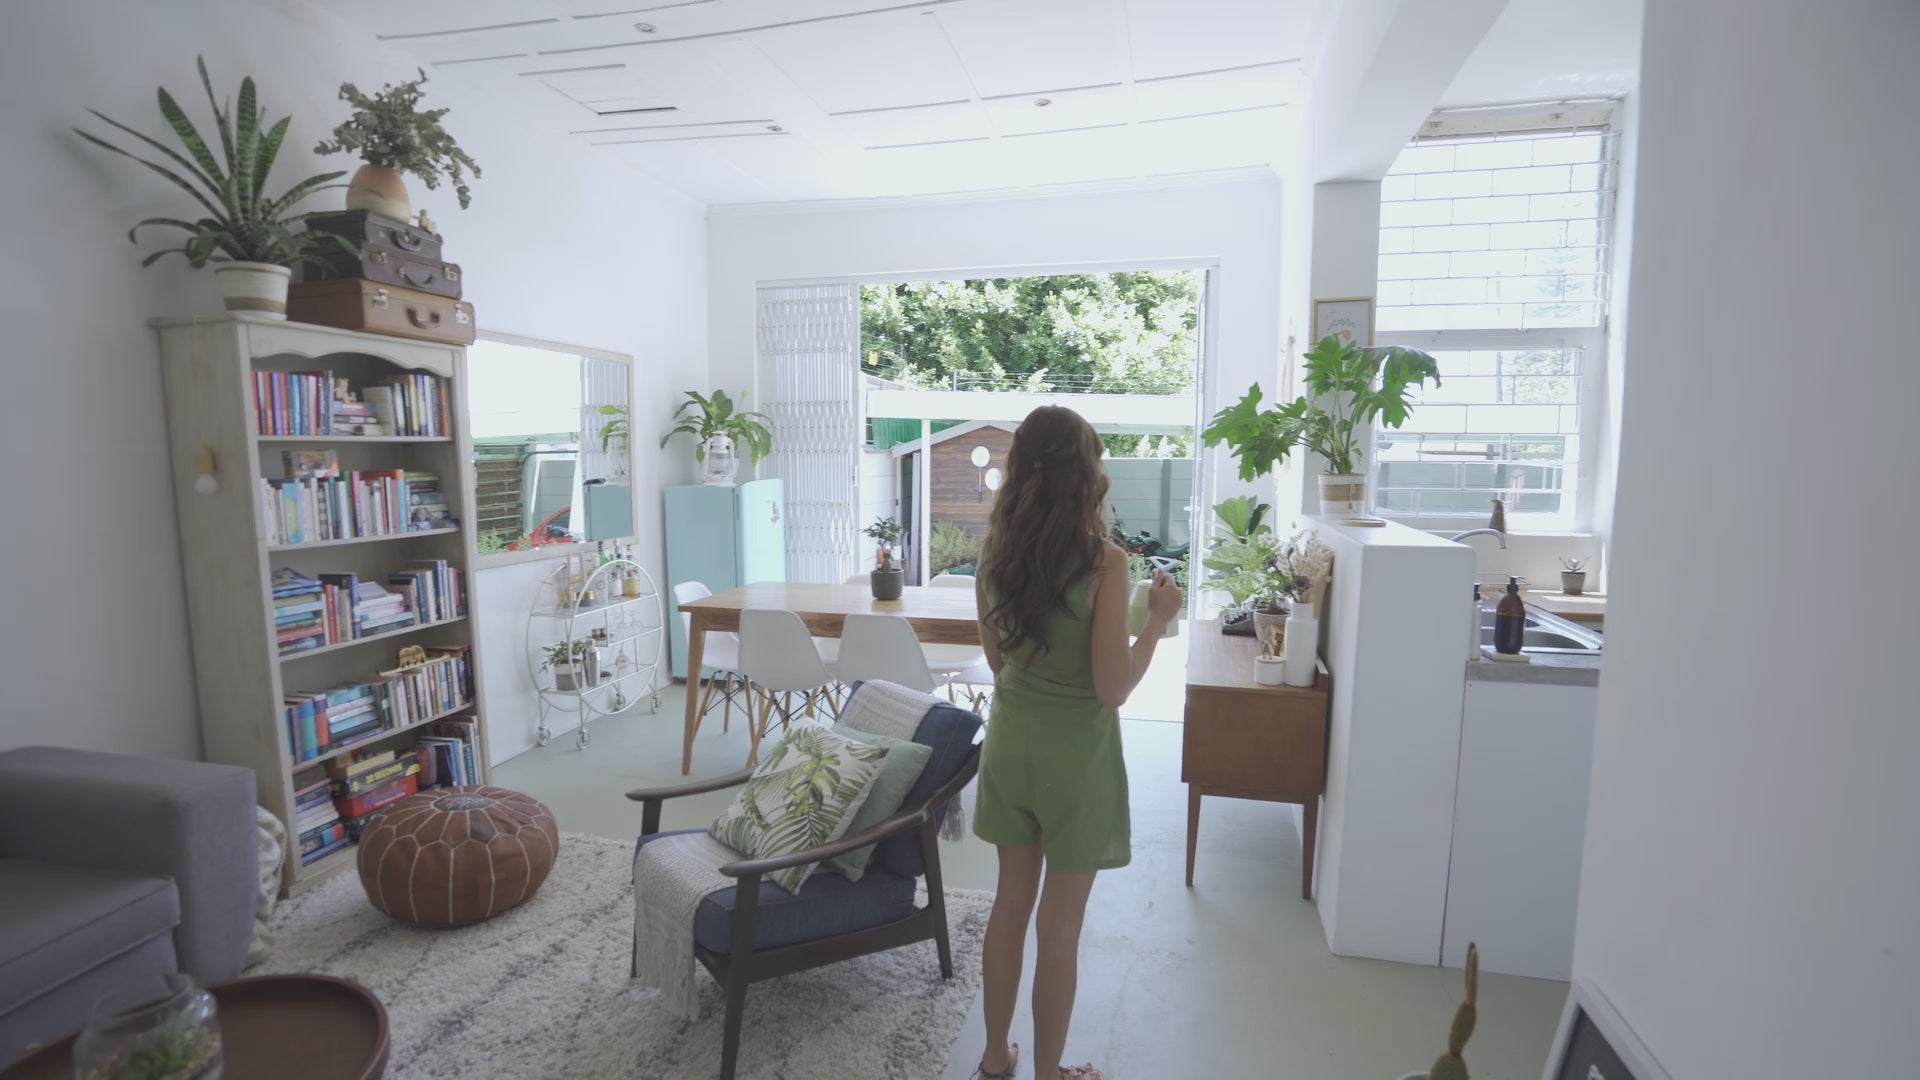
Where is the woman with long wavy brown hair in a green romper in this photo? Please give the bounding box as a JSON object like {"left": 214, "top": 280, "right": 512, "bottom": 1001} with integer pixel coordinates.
{"left": 973, "top": 405, "right": 1181, "bottom": 1080}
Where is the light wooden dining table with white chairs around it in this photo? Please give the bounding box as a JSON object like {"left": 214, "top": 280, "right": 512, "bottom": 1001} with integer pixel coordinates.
{"left": 680, "top": 582, "right": 979, "bottom": 776}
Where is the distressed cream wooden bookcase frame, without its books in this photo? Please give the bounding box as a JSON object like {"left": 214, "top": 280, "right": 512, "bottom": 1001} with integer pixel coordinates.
{"left": 152, "top": 313, "right": 488, "bottom": 892}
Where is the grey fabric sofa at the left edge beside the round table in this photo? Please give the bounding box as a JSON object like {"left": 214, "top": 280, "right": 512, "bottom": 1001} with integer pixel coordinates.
{"left": 0, "top": 746, "right": 259, "bottom": 1067}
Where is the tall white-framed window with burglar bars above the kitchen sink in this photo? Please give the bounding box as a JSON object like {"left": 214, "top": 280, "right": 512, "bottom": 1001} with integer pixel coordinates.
{"left": 1371, "top": 108, "right": 1615, "bottom": 530}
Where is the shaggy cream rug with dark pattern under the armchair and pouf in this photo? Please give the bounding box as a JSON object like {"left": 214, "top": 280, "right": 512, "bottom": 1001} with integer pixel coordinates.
{"left": 248, "top": 834, "right": 993, "bottom": 1080}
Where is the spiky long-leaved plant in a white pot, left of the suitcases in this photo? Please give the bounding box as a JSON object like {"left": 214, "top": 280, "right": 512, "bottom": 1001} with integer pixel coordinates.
{"left": 73, "top": 60, "right": 346, "bottom": 319}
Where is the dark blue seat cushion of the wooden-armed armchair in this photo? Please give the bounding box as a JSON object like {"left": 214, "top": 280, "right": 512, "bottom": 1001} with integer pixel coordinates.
{"left": 634, "top": 828, "right": 914, "bottom": 953}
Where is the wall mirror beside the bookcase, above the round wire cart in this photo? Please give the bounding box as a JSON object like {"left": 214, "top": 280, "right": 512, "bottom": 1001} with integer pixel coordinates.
{"left": 467, "top": 331, "right": 634, "bottom": 565}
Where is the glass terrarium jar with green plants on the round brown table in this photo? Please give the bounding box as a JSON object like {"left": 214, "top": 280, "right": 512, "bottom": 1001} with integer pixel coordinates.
{"left": 73, "top": 974, "right": 223, "bottom": 1080}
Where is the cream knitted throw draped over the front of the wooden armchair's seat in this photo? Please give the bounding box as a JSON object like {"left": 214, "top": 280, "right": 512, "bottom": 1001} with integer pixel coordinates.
{"left": 634, "top": 832, "right": 741, "bottom": 1017}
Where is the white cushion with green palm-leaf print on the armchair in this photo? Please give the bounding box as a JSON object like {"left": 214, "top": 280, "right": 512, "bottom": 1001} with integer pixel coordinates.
{"left": 707, "top": 724, "right": 887, "bottom": 894}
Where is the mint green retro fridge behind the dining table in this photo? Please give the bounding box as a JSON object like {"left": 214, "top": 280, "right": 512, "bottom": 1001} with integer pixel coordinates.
{"left": 666, "top": 480, "right": 787, "bottom": 678}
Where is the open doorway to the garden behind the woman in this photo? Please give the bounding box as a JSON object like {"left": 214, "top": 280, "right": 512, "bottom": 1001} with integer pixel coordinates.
{"left": 856, "top": 267, "right": 1208, "bottom": 721}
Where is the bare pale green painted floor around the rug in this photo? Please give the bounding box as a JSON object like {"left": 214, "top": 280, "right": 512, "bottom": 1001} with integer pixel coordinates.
{"left": 493, "top": 686, "right": 1565, "bottom": 1080}
